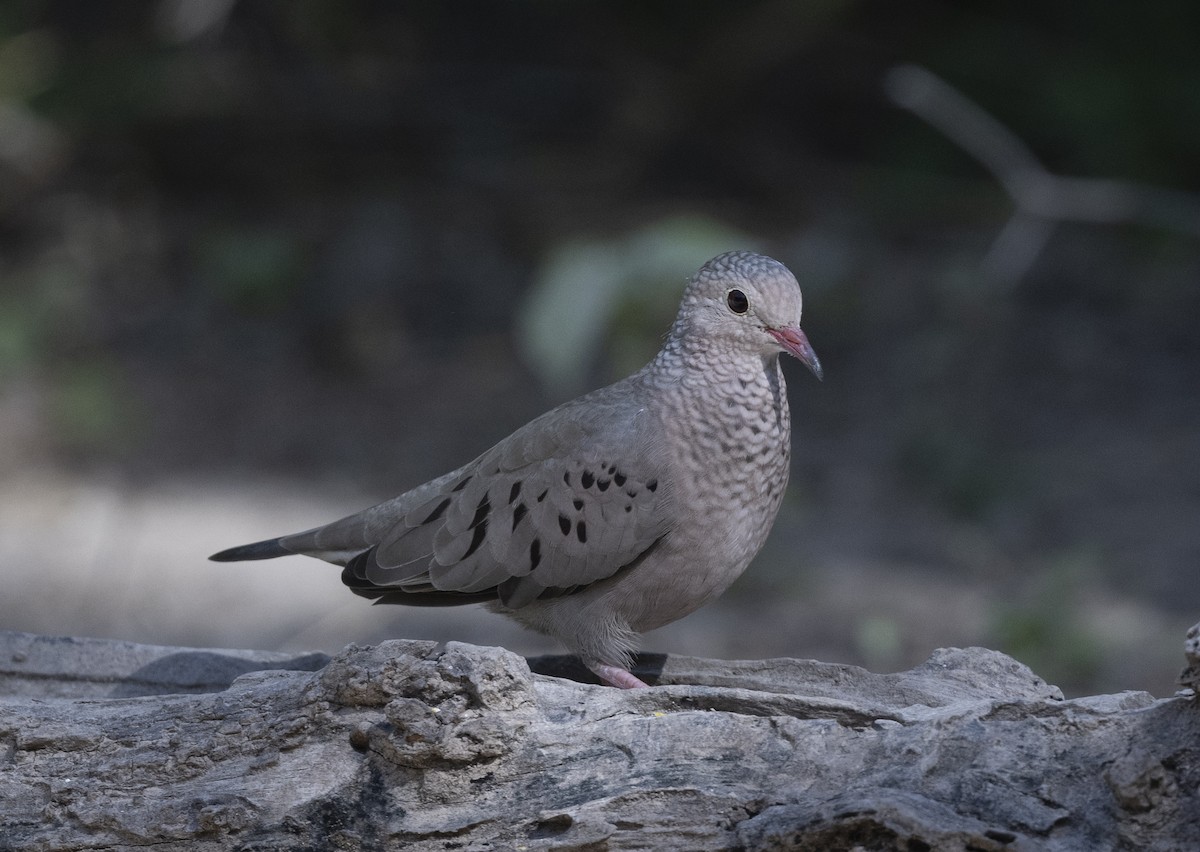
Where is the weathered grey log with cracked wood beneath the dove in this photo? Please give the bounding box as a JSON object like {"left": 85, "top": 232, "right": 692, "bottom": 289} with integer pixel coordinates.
{"left": 0, "top": 634, "right": 1200, "bottom": 852}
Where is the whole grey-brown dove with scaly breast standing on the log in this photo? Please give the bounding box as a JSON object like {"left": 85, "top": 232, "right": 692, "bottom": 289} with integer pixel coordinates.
{"left": 211, "top": 252, "right": 821, "bottom": 688}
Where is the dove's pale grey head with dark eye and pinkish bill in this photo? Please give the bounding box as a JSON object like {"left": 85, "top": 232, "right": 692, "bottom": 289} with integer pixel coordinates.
{"left": 677, "top": 252, "right": 822, "bottom": 379}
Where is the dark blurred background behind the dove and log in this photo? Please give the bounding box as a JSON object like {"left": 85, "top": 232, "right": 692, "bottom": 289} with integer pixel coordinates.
{"left": 0, "top": 0, "right": 1200, "bottom": 695}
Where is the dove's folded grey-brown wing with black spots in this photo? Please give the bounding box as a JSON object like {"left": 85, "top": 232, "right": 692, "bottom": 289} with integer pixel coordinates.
{"left": 280, "top": 383, "right": 671, "bottom": 607}
